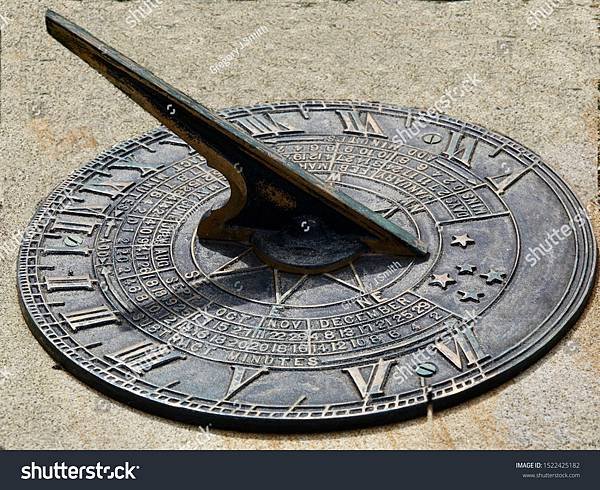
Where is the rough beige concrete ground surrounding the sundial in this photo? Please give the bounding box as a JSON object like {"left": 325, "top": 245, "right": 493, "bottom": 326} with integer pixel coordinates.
{"left": 0, "top": 0, "right": 600, "bottom": 449}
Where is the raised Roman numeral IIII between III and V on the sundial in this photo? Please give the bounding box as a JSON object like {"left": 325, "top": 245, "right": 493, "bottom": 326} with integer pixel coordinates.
{"left": 106, "top": 342, "right": 185, "bottom": 376}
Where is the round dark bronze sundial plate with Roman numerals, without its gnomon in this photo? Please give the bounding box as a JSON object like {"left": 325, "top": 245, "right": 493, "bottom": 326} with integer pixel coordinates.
{"left": 18, "top": 101, "right": 596, "bottom": 430}
